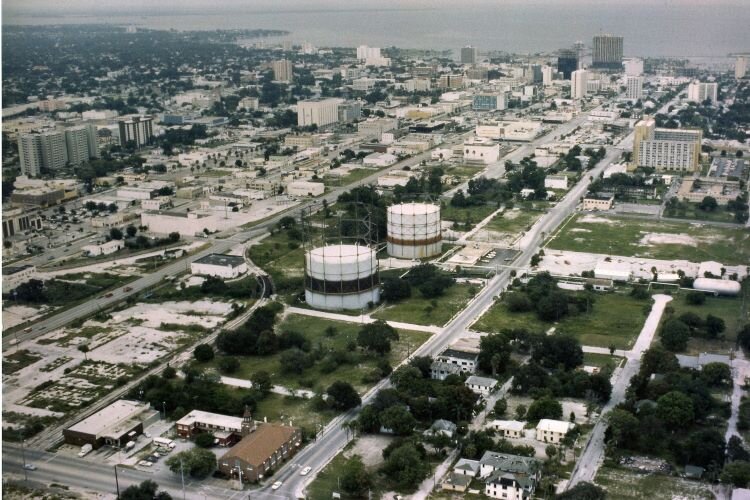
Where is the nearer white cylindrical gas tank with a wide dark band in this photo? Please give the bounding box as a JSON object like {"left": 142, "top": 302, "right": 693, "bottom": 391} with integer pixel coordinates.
{"left": 305, "top": 244, "right": 380, "bottom": 311}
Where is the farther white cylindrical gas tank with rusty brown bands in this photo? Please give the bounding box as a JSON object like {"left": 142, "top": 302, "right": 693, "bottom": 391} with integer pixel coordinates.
{"left": 387, "top": 203, "right": 443, "bottom": 259}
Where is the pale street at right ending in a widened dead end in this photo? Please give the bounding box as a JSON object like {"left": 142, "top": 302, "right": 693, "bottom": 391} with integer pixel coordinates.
{"left": 567, "top": 295, "right": 672, "bottom": 488}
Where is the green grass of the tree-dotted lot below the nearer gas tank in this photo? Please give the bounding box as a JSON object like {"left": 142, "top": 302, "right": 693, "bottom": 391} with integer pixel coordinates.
{"left": 209, "top": 314, "right": 430, "bottom": 393}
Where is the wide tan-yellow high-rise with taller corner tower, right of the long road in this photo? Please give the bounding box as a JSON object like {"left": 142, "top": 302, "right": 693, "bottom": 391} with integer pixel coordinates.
{"left": 633, "top": 117, "right": 703, "bottom": 173}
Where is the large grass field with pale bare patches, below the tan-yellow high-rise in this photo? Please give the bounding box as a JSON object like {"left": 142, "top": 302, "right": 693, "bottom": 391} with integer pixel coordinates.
{"left": 549, "top": 215, "right": 750, "bottom": 265}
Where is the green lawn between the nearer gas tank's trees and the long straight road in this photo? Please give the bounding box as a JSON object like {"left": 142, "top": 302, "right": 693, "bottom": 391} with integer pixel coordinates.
{"left": 372, "top": 284, "right": 479, "bottom": 326}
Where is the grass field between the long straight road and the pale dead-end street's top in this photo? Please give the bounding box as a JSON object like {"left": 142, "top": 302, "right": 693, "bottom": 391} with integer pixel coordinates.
{"left": 472, "top": 293, "right": 651, "bottom": 349}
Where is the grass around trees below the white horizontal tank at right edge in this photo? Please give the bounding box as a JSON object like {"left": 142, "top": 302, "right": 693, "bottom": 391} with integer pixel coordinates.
{"left": 667, "top": 286, "right": 750, "bottom": 354}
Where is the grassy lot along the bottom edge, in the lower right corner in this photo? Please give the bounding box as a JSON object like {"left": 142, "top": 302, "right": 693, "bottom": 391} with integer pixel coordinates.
{"left": 594, "top": 467, "right": 714, "bottom": 500}
